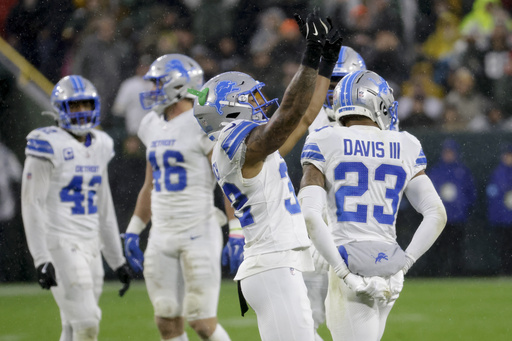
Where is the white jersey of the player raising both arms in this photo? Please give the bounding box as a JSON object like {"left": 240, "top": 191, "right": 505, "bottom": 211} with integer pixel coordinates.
{"left": 212, "top": 120, "right": 310, "bottom": 258}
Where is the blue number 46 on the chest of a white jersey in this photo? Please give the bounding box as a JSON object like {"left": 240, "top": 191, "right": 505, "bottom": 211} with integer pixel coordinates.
{"left": 149, "top": 150, "right": 187, "bottom": 192}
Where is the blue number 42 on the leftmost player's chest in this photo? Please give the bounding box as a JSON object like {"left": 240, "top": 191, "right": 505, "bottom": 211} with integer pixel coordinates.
{"left": 60, "top": 175, "right": 101, "bottom": 214}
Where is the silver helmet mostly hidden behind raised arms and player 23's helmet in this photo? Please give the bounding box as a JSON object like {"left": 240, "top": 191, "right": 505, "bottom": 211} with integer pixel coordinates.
{"left": 324, "top": 46, "right": 366, "bottom": 121}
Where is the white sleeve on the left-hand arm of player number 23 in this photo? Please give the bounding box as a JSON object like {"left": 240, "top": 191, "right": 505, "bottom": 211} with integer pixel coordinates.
{"left": 298, "top": 186, "right": 350, "bottom": 278}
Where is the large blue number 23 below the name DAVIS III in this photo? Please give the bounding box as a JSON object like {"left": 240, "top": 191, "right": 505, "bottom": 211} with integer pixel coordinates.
{"left": 334, "top": 162, "right": 407, "bottom": 225}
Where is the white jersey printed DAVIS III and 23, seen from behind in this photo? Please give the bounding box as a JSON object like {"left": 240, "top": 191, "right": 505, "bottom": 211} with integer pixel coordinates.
{"left": 301, "top": 125, "right": 427, "bottom": 245}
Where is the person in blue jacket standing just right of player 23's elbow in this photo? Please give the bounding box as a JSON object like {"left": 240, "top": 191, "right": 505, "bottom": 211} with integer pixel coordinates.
{"left": 427, "top": 139, "right": 476, "bottom": 276}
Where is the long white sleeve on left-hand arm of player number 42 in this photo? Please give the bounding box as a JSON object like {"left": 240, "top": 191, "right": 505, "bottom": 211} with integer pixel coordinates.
{"left": 21, "top": 156, "right": 53, "bottom": 268}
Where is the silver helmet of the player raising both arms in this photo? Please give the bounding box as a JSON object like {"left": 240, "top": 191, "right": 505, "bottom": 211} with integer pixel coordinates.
{"left": 190, "top": 72, "right": 279, "bottom": 140}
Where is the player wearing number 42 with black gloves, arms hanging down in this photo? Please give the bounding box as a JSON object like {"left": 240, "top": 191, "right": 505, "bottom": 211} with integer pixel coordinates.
{"left": 21, "top": 76, "right": 131, "bottom": 341}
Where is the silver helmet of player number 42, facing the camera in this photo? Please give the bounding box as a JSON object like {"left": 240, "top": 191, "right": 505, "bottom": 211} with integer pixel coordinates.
{"left": 50, "top": 75, "right": 100, "bottom": 136}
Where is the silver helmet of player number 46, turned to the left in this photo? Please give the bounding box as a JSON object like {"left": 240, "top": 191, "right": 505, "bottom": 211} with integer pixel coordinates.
{"left": 139, "top": 54, "right": 204, "bottom": 114}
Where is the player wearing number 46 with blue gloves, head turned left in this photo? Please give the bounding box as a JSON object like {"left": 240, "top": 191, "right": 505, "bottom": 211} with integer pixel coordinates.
{"left": 125, "top": 54, "right": 229, "bottom": 341}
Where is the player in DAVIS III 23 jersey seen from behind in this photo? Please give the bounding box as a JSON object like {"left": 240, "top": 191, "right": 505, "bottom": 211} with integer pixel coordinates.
{"left": 299, "top": 71, "right": 446, "bottom": 341}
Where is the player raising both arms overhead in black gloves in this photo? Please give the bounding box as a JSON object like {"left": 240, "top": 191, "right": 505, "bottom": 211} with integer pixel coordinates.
{"left": 194, "top": 12, "right": 341, "bottom": 341}
